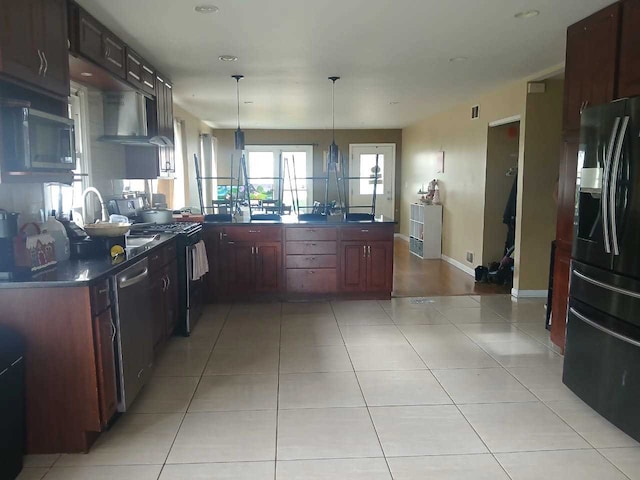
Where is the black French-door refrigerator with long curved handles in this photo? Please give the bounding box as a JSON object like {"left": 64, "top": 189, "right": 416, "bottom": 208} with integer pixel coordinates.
{"left": 563, "top": 98, "right": 640, "bottom": 440}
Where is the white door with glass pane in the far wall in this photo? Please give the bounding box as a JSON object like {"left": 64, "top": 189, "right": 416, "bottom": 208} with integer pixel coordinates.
{"left": 348, "top": 143, "right": 396, "bottom": 220}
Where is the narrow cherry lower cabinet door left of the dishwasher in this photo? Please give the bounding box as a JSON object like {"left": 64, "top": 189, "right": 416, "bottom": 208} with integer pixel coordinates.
{"left": 93, "top": 307, "right": 118, "bottom": 426}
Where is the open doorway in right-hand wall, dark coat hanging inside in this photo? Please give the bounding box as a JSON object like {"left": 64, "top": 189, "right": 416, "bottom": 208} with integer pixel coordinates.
{"left": 482, "top": 120, "right": 520, "bottom": 265}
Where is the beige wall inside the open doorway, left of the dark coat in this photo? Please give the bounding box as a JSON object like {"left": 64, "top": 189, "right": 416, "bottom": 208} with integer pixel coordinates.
{"left": 482, "top": 122, "right": 520, "bottom": 265}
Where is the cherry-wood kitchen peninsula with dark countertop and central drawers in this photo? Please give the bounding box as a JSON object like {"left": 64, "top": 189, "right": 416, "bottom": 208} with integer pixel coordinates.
{"left": 203, "top": 216, "right": 395, "bottom": 302}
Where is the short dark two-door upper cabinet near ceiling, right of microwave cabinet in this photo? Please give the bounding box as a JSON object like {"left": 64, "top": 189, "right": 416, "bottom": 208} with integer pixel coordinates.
{"left": 70, "top": 4, "right": 127, "bottom": 78}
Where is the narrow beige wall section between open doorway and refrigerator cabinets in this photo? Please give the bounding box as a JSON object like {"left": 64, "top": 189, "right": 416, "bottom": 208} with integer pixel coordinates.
{"left": 514, "top": 80, "right": 564, "bottom": 290}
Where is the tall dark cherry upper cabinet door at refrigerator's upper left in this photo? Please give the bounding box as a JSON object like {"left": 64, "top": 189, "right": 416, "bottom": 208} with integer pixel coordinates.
{"left": 564, "top": 4, "right": 621, "bottom": 133}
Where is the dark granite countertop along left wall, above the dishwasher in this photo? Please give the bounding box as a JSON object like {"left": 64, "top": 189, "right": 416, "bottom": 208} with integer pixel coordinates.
{"left": 0, "top": 233, "right": 175, "bottom": 288}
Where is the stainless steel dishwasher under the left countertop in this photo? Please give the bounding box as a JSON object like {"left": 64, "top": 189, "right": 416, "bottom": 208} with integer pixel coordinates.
{"left": 113, "top": 258, "right": 153, "bottom": 412}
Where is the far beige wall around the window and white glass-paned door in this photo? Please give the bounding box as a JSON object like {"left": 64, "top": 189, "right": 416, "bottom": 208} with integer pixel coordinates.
{"left": 213, "top": 130, "right": 402, "bottom": 219}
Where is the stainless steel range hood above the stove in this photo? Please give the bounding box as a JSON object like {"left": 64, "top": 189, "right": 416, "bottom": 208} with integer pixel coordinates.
{"left": 99, "top": 92, "right": 173, "bottom": 147}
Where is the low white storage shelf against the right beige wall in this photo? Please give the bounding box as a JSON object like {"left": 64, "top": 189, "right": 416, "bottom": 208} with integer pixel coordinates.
{"left": 409, "top": 203, "right": 442, "bottom": 259}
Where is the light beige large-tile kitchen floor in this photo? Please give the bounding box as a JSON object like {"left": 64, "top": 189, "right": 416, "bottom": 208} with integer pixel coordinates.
{"left": 19, "top": 295, "right": 640, "bottom": 480}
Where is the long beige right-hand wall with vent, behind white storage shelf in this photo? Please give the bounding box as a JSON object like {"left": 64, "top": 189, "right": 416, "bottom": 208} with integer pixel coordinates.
{"left": 400, "top": 80, "right": 527, "bottom": 268}
